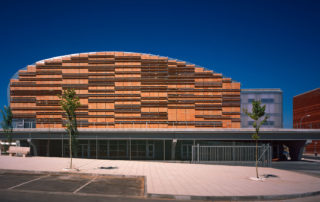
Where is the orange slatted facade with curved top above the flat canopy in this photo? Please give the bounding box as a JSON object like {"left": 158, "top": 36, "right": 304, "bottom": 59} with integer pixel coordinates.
{"left": 10, "top": 52, "right": 240, "bottom": 128}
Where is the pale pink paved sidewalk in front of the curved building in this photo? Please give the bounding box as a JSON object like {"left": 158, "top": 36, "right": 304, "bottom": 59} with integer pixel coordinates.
{"left": 0, "top": 156, "right": 320, "bottom": 200}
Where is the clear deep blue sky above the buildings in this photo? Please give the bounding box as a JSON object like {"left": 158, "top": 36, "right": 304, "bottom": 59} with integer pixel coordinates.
{"left": 0, "top": 0, "right": 320, "bottom": 128}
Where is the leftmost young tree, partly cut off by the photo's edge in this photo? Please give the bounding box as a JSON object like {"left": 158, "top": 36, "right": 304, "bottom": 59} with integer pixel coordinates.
{"left": 1, "top": 106, "right": 13, "bottom": 150}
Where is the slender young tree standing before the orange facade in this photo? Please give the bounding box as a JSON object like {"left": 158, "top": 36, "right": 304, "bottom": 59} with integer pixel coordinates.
{"left": 58, "top": 89, "right": 80, "bottom": 169}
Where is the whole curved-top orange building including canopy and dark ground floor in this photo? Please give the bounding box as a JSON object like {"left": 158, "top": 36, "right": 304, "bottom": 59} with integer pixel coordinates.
{"left": 0, "top": 52, "right": 319, "bottom": 161}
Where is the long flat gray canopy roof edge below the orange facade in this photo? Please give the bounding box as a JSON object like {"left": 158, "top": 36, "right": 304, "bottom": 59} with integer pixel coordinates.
{"left": 0, "top": 128, "right": 320, "bottom": 141}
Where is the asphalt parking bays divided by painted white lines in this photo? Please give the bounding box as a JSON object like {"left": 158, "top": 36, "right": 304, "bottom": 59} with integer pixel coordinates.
{"left": 0, "top": 172, "right": 144, "bottom": 197}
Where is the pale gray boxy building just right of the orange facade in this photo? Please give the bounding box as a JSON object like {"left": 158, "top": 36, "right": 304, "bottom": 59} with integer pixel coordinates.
{"left": 241, "top": 89, "right": 283, "bottom": 128}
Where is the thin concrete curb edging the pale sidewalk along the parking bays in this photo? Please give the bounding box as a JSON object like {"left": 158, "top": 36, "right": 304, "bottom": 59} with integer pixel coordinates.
{"left": 0, "top": 169, "right": 320, "bottom": 201}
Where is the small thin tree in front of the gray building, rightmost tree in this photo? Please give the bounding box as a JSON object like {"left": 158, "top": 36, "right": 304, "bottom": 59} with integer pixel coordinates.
{"left": 244, "top": 100, "right": 269, "bottom": 178}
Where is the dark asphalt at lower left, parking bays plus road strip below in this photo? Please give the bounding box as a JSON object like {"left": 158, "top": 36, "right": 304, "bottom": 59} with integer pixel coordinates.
{"left": 0, "top": 171, "right": 145, "bottom": 201}
